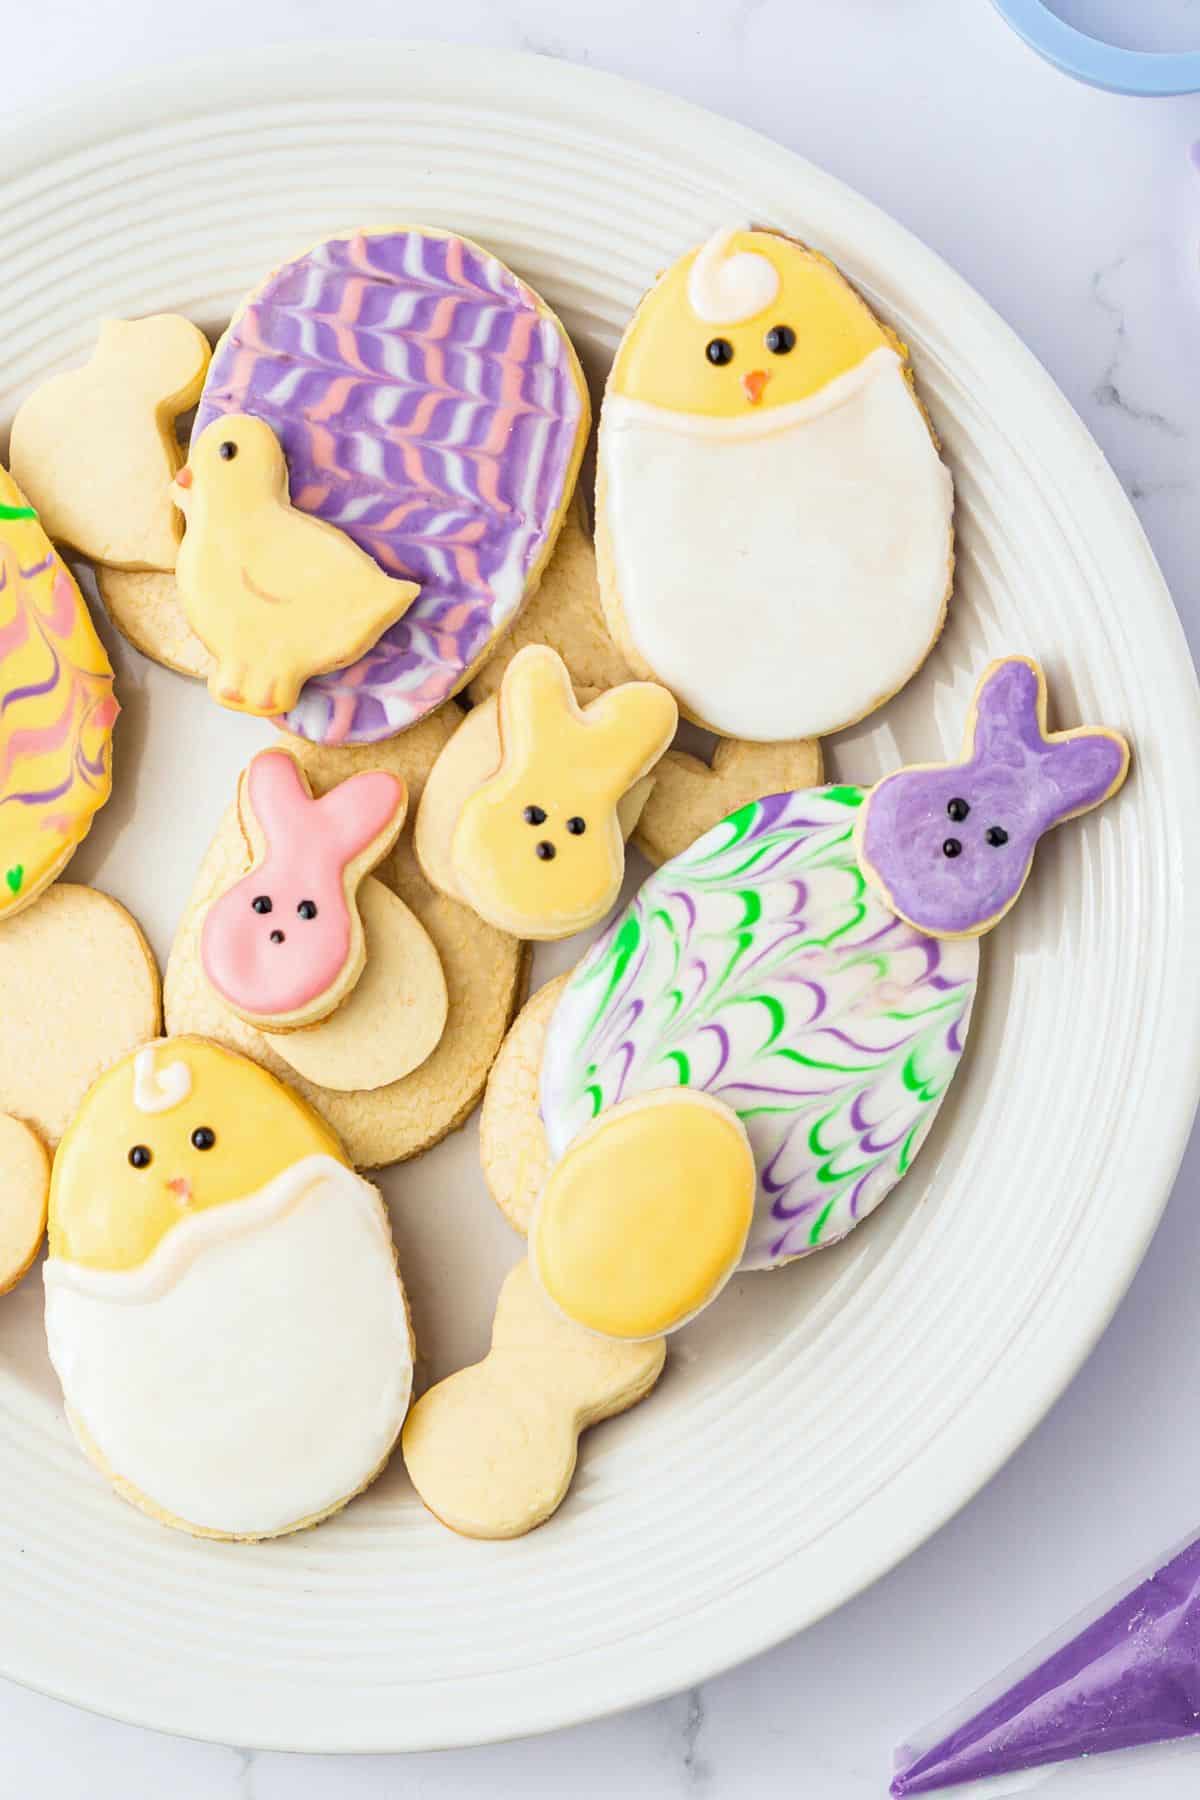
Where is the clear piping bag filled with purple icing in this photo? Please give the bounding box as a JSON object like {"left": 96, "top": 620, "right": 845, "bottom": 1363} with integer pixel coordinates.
{"left": 891, "top": 1537, "right": 1200, "bottom": 1800}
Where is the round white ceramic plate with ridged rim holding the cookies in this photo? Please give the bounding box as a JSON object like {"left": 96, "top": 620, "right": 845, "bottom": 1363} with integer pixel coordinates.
{"left": 0, "top": 45, "right": 1200, "bottom": 1750}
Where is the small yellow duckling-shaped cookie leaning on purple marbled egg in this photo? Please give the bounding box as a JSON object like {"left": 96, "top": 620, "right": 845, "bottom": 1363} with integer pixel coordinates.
{"left": 173, "top": 412, "right": 417, "bottom": 718}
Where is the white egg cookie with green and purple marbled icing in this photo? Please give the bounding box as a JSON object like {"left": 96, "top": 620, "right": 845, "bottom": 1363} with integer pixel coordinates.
{"left": 542, "top": 787, "right": 979, "bottom": 1269}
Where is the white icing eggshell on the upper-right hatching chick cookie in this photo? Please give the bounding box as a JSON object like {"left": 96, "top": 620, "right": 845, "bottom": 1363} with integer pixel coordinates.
{"left": 599, "top": 347, "right": 954, "bottom": 742}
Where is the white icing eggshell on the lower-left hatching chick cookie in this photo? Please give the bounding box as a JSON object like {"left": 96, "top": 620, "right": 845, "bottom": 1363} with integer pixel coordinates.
{"left": 45, "top": 1156, "right": 412, "bottom": 1535}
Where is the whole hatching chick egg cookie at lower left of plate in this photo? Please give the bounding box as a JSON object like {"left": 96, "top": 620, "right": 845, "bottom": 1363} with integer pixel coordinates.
{"left": 45, "top": 1037, "right": 412, "bottom": 1539}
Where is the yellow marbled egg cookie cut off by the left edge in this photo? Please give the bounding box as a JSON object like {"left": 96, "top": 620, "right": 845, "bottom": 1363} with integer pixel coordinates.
{"left": 0, "top": 468, "right": 119, "bottom": 920}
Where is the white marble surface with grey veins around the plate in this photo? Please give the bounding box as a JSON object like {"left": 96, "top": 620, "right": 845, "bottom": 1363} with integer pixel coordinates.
{"left": 0, "top": 0, "right": 1200, "bottom": 1800}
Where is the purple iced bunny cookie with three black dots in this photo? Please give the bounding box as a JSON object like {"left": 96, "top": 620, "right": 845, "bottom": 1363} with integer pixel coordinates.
{"left": 858, "top": 657, "right": 1130, "bottom": 938}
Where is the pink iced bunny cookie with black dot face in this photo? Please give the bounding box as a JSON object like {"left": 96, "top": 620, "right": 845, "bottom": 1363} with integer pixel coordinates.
{"left": 200, "top": 751, "right": 407, "bottom": 1031}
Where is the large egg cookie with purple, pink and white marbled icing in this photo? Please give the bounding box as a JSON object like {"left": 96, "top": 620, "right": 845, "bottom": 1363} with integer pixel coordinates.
{"left": 196, "top": 227, "right": 588, "bottom": 743}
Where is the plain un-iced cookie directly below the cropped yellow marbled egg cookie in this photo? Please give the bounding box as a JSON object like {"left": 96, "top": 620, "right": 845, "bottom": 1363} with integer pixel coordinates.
{"left": 0, "top": 882, "right": 162, "bottom": 1150}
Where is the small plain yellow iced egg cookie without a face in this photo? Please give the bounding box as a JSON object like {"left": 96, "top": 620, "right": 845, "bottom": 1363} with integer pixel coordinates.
{"left": 529, "top": 1087, "right": 757, "bottom": 1339}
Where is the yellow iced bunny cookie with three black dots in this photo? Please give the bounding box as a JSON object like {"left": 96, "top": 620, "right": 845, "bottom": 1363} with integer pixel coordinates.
{"left": 431, "top": 644, "right": 678, "bottom": 940}
